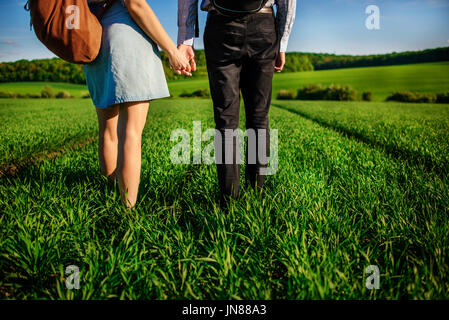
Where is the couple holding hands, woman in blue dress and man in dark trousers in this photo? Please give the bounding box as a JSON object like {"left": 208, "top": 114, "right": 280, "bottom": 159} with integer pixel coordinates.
{"left": 84, "top": 0, "right": 296, "bottom": 207}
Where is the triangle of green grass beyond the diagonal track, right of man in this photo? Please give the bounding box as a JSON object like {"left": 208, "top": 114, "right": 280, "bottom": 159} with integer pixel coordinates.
{"left": 273, "top": 101, "right": 449, "bottom": 172}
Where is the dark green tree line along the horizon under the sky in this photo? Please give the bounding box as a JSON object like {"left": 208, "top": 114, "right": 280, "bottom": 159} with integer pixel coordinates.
{"left": 0, "top": 47, "right": 449, "bottom": 84}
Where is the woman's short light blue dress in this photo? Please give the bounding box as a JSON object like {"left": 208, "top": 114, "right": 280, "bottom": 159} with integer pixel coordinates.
{"left": 84, "top": 1, "right": 170, "bottom": 108}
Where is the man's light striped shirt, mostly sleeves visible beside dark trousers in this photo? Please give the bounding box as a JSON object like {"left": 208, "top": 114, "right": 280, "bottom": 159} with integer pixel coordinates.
{"left": 178, "top": 0, "right": 296, "bottom": 52}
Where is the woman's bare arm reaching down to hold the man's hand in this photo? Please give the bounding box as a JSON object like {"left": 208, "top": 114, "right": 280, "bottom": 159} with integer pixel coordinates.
{"left": 125, "top": 0, "right": 191, "bottom": 75}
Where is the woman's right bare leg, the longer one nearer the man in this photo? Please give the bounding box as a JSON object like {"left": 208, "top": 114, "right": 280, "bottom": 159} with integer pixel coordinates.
{"left": 117, "top": 101, "right": 149, "bottom": 208}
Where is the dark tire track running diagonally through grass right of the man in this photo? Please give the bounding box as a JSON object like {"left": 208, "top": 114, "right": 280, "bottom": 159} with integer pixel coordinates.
{"left": 272, "top": 104, "right": 448, "bottom": 177}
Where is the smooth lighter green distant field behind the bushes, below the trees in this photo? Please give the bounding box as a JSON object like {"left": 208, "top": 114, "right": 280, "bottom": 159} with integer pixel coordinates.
{"left": 0, "top": 62, "right": 449, "bottom": 101}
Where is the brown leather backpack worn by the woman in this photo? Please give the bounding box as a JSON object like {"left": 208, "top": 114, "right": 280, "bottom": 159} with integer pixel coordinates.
{"left": 25, "top": 0, "right": 115, "bottom": 64}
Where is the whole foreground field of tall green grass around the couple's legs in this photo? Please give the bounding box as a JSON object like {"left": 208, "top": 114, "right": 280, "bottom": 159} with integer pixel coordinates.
{"left": 0, "top": 94, "right": 449, "bottom": 299}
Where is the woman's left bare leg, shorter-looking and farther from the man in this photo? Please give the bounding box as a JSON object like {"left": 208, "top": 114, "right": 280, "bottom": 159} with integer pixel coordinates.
{"left": 97, "top": 105, "right": 119, "bottom": 181}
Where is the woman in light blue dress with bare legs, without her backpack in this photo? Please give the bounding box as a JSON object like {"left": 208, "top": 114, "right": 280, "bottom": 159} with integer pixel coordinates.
{"left": 84, "top": 0, "right": 191, "bottom": 208}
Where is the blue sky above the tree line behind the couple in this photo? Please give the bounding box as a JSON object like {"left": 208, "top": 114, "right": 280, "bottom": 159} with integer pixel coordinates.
{"left": 0, "top": 0, "right": 449, "bottom": 61}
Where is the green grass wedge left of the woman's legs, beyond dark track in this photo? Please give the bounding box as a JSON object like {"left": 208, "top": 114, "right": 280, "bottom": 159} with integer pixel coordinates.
{"left": 0, "top": 99, "right": 98, "bottom": 167}
